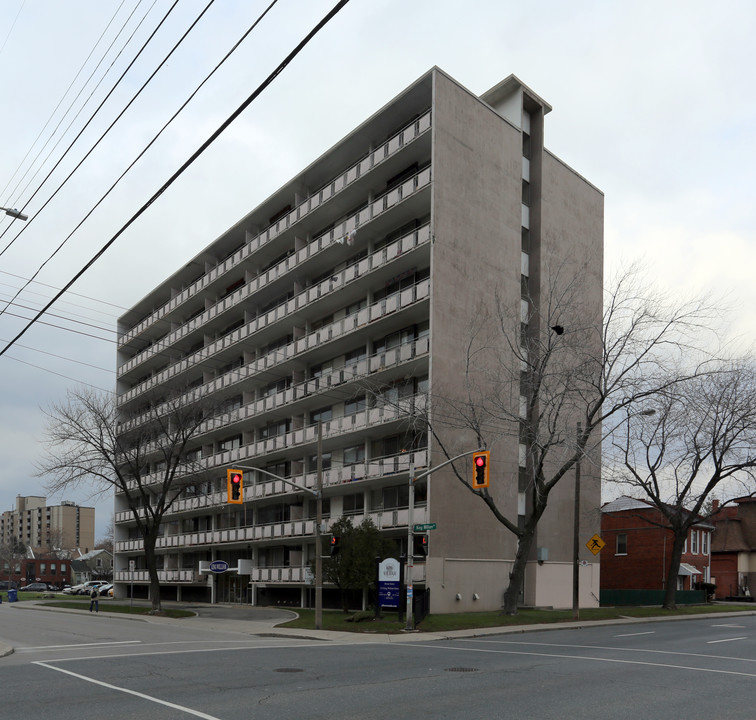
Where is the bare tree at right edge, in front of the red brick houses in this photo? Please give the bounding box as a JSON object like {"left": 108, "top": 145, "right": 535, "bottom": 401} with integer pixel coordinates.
{"left": 609, "top": 362, "right": 756, "bottom": 609}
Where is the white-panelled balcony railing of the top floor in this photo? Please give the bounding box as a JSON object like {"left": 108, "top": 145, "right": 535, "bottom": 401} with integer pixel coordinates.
{"left": 118, "top": 107, "right": 431, "bottom": 348}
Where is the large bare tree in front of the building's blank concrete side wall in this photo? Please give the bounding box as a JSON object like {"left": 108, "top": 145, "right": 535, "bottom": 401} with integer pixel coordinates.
{"left": 392, "top": 265, "right": 715, "bottom": 615}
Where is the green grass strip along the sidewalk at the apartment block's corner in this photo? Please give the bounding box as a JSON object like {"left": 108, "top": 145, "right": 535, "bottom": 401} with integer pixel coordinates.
{"left": 278, "top": 605, "right": 756, "bottom": 633}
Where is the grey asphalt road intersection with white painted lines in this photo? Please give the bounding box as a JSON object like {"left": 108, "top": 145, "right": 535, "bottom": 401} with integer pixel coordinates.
{"left": 0, "top": 606, "right": 756, "bottom": 720}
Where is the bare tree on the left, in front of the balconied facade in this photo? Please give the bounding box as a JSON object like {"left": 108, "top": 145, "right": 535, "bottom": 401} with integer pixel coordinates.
{"left": 38, "top": 388, "right": 214, "bottom": 612}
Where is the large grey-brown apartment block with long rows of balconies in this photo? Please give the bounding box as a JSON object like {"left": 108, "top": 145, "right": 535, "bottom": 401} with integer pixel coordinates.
{"left": 114, "top": 68, "right": 603, "bottom": 612}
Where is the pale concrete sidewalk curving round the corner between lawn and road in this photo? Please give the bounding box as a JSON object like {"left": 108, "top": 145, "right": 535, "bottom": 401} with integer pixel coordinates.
{"left": 0, "top": 601, "right": 756, "bottom": 657}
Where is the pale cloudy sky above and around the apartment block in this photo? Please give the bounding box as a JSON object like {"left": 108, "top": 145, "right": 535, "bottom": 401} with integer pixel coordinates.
{"left": 0, "top": 0, "right": 756, "bottom": 537}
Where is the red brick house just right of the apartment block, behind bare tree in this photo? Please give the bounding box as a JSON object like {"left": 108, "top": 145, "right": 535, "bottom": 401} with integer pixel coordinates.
{"left": 601, "top": 496, "right": 714, "bottom": 591}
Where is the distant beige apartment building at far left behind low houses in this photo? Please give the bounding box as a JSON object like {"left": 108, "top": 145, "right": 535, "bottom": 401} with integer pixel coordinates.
{"left": 0, "top": 495, "right": 95, "bottom": 551}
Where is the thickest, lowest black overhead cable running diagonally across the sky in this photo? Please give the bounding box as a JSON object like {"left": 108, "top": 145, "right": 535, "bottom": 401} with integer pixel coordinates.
{"left": 0, "top": 0, "right": 349, "bottom": 357}
